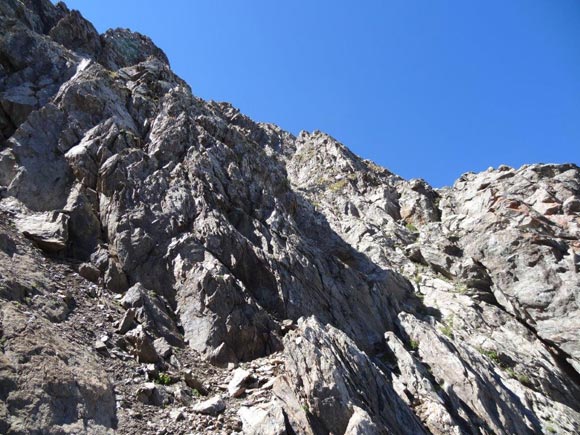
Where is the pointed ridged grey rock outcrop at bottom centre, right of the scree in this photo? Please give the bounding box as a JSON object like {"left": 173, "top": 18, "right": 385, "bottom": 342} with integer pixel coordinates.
{"left": 284, "top": 318, "right": 428, "bottom": 434}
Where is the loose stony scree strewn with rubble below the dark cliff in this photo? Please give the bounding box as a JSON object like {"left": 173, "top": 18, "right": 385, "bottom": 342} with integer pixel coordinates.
{"left": 0, "top": 210, "right": 284, "bottom": 434}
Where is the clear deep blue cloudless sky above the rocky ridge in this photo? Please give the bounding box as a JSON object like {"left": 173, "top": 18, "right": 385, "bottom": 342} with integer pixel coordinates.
{"left": 60, "top": 0, "right": 580, "bottom": 187}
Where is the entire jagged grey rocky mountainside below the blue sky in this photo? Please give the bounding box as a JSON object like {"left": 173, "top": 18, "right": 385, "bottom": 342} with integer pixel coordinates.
{"left": 0, "top": 0, "right": 580, "bottom": 435}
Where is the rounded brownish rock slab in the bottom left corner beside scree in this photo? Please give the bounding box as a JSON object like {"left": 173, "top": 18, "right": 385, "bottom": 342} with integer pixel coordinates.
{"left": 0, "top": 303, "right": 117, "bottom": 434}
